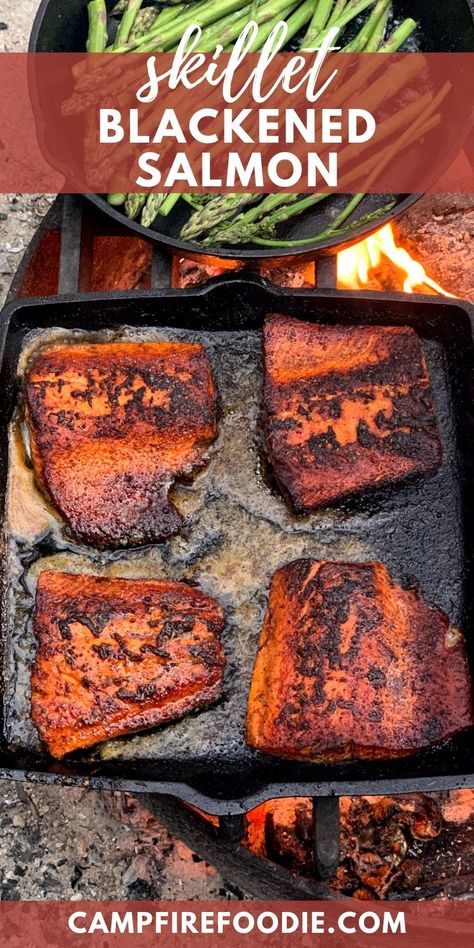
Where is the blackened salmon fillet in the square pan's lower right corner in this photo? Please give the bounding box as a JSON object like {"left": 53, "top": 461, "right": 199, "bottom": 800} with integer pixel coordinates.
{"left": 247, "top": 559, "right": 473, "bottom": 762}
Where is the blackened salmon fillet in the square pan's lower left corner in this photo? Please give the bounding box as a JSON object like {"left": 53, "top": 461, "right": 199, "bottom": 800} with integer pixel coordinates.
{"left": 31, "top": 571, "right": 225, "bottom": 758}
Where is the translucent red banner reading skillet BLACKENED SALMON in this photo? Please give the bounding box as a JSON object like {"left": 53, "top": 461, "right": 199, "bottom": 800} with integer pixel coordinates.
{"left": 0, "top": 53, "right": 474, "bottom": 193}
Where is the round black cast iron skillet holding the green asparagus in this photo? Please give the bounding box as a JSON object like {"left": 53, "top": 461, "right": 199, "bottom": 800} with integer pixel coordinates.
{"left": 30, "top": 0, "right": 474, "bottom": 262}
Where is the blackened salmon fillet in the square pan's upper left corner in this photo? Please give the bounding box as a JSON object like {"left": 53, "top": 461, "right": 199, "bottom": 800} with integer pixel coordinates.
{"left": 26, "top": 342, "right": 217, "bottom": 548}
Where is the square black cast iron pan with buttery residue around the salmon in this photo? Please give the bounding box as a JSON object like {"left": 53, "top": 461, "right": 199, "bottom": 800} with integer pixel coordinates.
{"left": 0, "top": 274, "right": 474, "bottom": 813}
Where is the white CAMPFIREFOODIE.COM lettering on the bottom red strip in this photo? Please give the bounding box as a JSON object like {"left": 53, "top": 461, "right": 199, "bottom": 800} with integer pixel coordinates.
{"left": 68, "top": 910, "right": 406, "bottom": 937}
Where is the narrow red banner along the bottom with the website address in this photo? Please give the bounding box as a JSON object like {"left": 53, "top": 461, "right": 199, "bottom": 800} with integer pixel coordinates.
{"left": 0, "top": 900, "right": 474, "bottom": 948}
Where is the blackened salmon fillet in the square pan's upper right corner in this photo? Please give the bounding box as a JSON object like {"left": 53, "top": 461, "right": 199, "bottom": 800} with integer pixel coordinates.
{"left": 264, "top": 315, "right": 441, "bottom": 513}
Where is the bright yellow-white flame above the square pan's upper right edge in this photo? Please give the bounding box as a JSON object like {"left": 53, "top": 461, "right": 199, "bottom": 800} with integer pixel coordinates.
{"left": 337, "top": 224, "right": 455, "bottom": 299}
